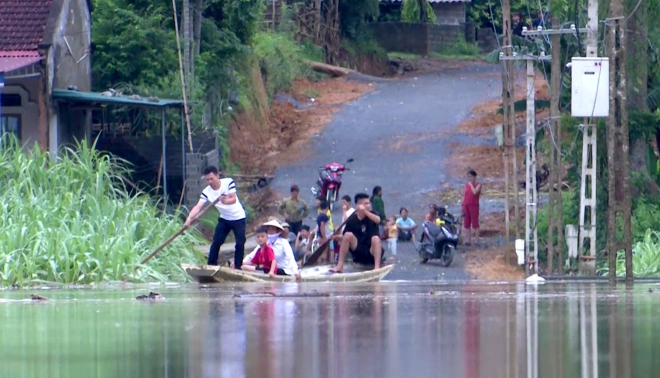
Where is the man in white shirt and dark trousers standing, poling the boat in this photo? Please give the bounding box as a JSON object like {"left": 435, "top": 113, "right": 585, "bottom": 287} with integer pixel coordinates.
{"left": 185, "top": 166, "right": 245, "bottom": 269}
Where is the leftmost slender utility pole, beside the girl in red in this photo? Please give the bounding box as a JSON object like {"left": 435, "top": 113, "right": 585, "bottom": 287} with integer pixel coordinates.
{"left": 501, "top": 0, "right": 518, "bottom": 263}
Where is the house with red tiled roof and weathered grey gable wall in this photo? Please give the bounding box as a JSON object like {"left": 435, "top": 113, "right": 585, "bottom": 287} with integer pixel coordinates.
{"left": 0, "top": 0, "right": 91, "bottom": 153}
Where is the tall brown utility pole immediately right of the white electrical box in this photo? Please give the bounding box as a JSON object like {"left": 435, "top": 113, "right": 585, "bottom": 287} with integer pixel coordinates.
{"left": 607, "top": 0, "right": 632, "bottom": 284}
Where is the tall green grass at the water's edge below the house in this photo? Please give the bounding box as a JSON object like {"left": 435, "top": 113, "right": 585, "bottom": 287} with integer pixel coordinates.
{"left": 0, "top": 138, "right": 202, "bottom": 286}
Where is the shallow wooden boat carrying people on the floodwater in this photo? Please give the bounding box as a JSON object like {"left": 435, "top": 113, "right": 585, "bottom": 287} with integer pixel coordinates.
{"left": 181, "top": 264, "right": 394, "bottom": 283}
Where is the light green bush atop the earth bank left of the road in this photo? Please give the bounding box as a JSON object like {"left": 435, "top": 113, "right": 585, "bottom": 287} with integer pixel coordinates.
{"left": 253, "top": 32, "right": 304, "bottom": 98}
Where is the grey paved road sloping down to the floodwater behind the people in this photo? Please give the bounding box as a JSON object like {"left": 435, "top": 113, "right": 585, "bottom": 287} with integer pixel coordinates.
{"left": 273, "top": 64, "right": 501, "bottom": 280}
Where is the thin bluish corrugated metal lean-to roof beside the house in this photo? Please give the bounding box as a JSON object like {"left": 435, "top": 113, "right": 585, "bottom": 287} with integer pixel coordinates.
{"left": 53, "top": 89, "right": 183, "bottom": 108}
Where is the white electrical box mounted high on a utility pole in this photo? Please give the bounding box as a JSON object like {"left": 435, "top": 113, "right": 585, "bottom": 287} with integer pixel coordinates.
{"left": 571, "top": 57, "right": 610, "bottom": 118}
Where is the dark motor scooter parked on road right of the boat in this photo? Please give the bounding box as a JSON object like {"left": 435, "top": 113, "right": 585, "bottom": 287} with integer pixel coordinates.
{"left": 415, "top": 207, "right": 461, "bottom": 267}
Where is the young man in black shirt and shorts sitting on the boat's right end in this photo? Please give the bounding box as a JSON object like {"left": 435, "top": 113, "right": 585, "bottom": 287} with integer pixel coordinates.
{"left": 330, "top": 193, "right": 383, "bottom": 273}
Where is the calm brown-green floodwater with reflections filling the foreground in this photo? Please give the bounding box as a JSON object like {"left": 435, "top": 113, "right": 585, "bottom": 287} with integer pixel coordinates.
{"left": 0, "top": 282, "right": 660, "bottom": 378}
